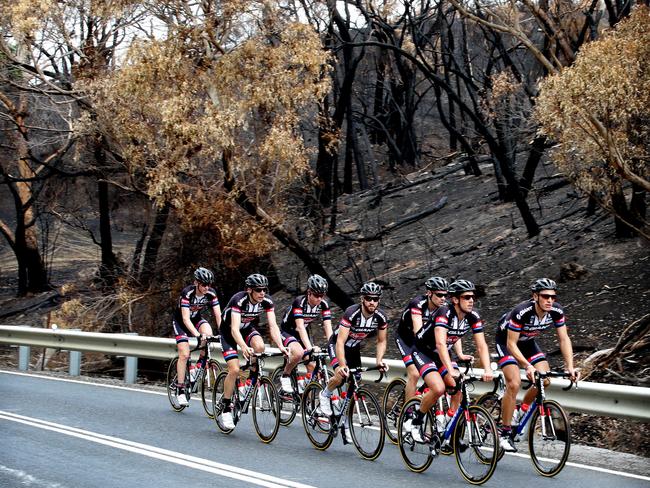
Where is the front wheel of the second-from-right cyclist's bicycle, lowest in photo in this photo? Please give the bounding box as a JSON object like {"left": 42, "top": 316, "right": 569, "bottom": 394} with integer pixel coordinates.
{"left": 453, "top": 405, "right": 499, "bottom": 485}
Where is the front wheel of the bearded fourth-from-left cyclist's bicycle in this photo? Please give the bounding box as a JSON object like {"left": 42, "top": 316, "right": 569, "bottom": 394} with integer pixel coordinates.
{"left": 348, "top": 387, "right": 386, "bottom": 461}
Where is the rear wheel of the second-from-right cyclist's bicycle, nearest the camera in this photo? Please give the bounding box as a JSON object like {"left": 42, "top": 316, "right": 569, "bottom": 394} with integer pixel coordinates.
{"left": 397, "top": 398, "right": 432, "bottom": 473}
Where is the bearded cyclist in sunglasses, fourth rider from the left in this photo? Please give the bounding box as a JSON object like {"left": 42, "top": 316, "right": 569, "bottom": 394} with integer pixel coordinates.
{"left": 320, "top": 281, "right": 388, "bottom": 443}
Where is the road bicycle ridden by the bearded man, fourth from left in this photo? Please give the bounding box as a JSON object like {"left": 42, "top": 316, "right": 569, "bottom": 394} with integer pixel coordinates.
{"left": 301, "top": 366, "right": 385, "bottom": 461}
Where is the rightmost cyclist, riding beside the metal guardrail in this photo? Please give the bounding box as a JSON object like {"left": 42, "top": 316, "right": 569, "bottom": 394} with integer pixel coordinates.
{"left": 495, "top": 278, "right": 580, "bottom": 452}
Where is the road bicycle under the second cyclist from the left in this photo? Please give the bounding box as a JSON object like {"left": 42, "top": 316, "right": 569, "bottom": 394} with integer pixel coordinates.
{"left": 212, "top": 352, "right": 283, "bottom": 443}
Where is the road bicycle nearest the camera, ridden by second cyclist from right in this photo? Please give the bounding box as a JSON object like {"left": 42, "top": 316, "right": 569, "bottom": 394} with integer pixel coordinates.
{"left": 397, "top": 361, "right": 499, "bottom": 485}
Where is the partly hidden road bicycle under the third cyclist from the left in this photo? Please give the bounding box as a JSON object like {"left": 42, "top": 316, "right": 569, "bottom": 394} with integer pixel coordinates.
{"left": 271, "top": 351, "right": 333, "bottom": 426}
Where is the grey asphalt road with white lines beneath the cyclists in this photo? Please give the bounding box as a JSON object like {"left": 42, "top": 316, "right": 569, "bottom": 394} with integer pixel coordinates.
{"left": 0, "top": 371, "right": 650, "bottom": 488}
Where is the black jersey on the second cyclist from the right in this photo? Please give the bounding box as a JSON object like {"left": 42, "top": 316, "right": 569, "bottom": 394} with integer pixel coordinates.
{"left": 415, "top": 305, "right": 483, "bottom": 356}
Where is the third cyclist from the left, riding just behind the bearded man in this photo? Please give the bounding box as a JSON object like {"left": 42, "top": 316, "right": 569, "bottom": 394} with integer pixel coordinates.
{"left": 280, "top": 274, "right": 332, "bottom": 393}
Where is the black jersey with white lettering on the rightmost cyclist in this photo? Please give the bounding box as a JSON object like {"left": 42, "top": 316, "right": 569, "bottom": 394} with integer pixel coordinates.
{"left": 496, "top": 300, "right": 565, "bottom": 342}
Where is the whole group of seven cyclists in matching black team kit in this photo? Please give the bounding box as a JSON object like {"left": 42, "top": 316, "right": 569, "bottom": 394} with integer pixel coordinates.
{"left": 173, "top": 267, "right": 579, "bottom": 452}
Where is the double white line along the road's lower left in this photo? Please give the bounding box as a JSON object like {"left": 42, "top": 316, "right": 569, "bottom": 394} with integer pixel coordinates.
{"left": 0, "top": 410, "right": 313, "bottom": 488}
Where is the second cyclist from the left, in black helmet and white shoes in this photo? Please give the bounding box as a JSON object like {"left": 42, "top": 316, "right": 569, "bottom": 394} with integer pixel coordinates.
{"left": 216, "top": 273, "right": 287, "bottom": 429}
